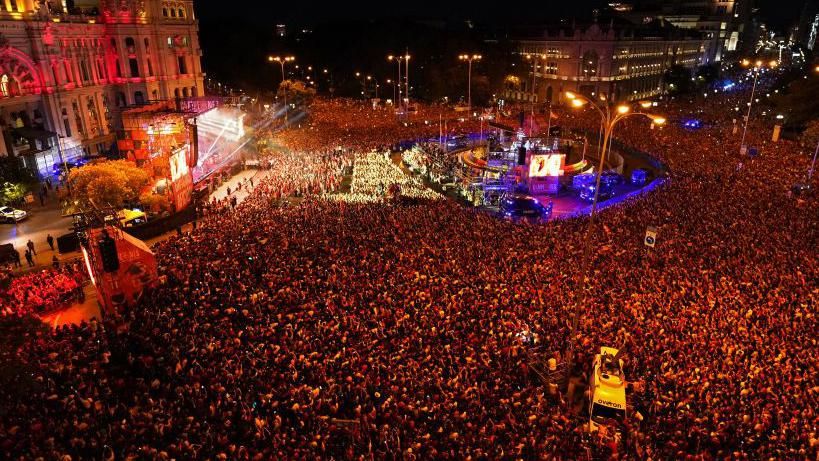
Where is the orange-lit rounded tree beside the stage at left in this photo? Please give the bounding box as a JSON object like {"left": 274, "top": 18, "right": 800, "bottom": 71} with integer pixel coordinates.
{"left": 68, "top": 160, "right": 150, "bottom": 208}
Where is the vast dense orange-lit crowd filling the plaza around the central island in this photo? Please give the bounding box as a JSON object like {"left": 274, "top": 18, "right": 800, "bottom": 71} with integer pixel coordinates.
{"left": 0, "top": 77, "right": 819, "bottom": 460}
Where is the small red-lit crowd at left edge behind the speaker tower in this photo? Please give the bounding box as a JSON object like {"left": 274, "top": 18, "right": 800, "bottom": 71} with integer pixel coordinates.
{"left": 0, "top": 262, "right": 88, "bottom": 317}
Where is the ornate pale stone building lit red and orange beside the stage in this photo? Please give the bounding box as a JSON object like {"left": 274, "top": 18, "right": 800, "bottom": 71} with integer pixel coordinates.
{"left": 0, "top": 0, "right": 204, "bottom": 174}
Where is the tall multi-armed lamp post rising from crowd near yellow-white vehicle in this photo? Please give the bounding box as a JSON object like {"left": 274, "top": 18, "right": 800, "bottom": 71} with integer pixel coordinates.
{"left": 565, "top": 92, "right": 666, "bottom": 383}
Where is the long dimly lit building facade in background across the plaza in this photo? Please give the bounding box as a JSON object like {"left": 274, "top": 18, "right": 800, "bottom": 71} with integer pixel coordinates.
{"left": 505, "top": 22, "right": 707, "bottom": 102}
